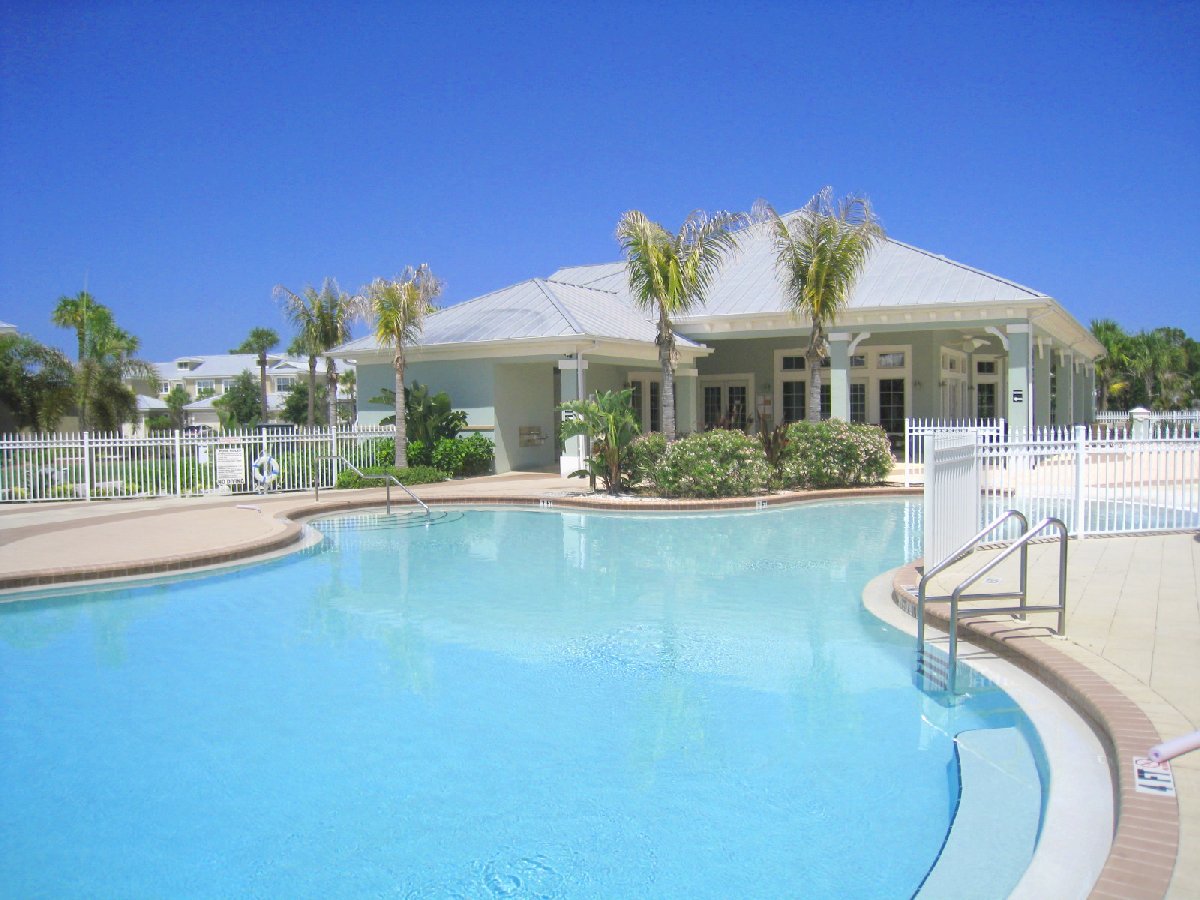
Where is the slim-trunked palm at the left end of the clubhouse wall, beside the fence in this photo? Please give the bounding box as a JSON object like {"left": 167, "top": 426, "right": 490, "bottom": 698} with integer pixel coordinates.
{"left": 354, "top": 263, "right": 442, "bottom": 468}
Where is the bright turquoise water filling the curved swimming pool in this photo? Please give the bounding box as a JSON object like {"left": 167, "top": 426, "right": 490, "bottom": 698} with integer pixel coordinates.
{"left": 0, "top": 500, "right": 1041, "bottom": 898}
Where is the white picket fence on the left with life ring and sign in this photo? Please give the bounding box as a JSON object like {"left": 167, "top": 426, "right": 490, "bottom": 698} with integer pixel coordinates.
{"left": 0, "top": 427, "right": 396, "bottom": 503}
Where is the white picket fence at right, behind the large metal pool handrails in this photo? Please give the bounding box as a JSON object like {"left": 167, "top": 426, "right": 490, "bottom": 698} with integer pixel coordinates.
{"left": 925, "top": 425, "right": 1200, "bottom": 562}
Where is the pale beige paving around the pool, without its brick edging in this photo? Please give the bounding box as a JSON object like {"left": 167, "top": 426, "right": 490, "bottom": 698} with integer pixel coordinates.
{"left": 0, "top": 474, "right": 1200, "bottom": 898}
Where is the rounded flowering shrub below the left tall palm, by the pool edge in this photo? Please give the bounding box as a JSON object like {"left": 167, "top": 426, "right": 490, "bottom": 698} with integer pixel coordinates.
{"left": 650, "top": 428, "right": 769, "bottom": 497}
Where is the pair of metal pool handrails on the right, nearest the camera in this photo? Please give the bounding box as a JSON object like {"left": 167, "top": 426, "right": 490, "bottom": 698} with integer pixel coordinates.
{"left": 917, "top": 509, "right": 1067, "bottom": 694}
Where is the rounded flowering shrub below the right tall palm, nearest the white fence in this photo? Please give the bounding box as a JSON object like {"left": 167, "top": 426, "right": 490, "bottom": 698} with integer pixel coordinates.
{"left": 779, "top": 419, "right": 895, "bottom": 487}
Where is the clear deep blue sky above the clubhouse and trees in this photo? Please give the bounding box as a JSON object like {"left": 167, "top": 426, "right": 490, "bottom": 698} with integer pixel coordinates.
{"left": 0, "top": 0, "right": 1200, "bottom": 360}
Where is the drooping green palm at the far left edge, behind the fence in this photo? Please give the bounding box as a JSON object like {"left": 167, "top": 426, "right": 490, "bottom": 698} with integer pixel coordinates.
{"left": 0, "top": 335, "right": 74, "bottom": 431}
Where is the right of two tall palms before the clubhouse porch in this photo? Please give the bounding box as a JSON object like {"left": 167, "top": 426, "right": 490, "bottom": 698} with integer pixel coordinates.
{"left": 755, "top": 187, "right": 887, "bottom": 421}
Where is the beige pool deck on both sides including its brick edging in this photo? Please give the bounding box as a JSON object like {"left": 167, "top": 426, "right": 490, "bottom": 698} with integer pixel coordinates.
{"left": 0, "top": 474, "right": 1200, "bottom": 898}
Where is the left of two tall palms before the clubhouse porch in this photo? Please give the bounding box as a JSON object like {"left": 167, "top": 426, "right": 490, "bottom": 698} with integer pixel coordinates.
{"left": 617, "top": 210, "right": 746, "bottom": 440}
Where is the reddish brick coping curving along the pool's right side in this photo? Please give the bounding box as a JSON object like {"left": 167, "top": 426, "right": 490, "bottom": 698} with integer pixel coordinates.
{"left": 892, "top": 559, "right": 1180, "bottom": 900}
